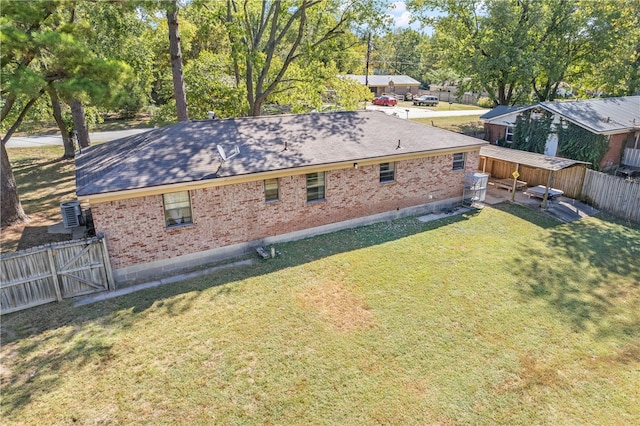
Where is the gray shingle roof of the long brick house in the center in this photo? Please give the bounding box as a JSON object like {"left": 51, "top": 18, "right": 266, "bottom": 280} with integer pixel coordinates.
{"left": 76, "top": 111, "right": 486, "bottom": 196}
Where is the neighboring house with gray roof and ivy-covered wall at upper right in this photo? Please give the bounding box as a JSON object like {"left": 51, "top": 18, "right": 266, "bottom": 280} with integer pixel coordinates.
{"left": 480, "top": 96, "right": 640, "bottom": 169}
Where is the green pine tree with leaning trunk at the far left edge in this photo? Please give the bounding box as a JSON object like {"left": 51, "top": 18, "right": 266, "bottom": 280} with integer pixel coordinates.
{"left": 0, "top": 1, "right": 125, "bottom": 225}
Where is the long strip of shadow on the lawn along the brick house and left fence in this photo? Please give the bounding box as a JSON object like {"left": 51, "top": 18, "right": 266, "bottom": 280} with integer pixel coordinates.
{"left": 1, "top": 211, "right": 478, "bottom": 414}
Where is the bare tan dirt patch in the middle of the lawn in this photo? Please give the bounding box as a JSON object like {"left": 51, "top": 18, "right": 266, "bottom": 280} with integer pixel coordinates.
{"left": 298, "top": 281, "right": 375, "bottom": 333}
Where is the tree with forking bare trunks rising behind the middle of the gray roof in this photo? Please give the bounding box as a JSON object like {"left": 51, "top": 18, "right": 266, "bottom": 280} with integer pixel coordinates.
{"left": 220, "top": 0, "right": 390, "bottom": 116}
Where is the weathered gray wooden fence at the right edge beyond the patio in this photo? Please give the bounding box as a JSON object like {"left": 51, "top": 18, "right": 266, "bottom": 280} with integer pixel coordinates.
{"left": 582, "top": 170, "right": 640, "bottom": 222}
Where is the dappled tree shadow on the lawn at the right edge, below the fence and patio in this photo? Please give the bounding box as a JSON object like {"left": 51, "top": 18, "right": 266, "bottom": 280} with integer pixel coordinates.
{"left": 512, "top": 217, "right": 640, "bottom": 339}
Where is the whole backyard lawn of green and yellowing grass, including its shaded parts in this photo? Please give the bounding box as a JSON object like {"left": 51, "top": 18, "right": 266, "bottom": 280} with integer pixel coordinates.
{"left": 2, "top": 204, "right": 640, "bottom": 425}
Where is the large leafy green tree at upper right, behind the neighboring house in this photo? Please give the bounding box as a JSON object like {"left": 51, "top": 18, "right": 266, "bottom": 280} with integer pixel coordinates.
{"left": 408, "top": 0, "right": 640, "bottom": 105}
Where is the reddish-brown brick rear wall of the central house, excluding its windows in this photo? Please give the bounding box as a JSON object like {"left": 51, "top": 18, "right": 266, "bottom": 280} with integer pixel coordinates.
{"left": 91, "top": 151, "right": 479, "bottom": 269}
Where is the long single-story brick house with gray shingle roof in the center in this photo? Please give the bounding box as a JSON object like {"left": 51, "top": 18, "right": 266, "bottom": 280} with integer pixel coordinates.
{"left": 76, "top": 111, "right": 486, "bottom": 282}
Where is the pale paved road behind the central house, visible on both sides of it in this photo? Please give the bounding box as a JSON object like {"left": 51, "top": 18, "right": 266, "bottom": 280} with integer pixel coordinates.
{"left": 7, "top": 105, "right": 489, "bottom": 148}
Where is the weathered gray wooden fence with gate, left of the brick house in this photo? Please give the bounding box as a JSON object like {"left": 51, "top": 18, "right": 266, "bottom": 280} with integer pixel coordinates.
{"left": 0, "top": 235, "right": 115, "bottom": 314}
